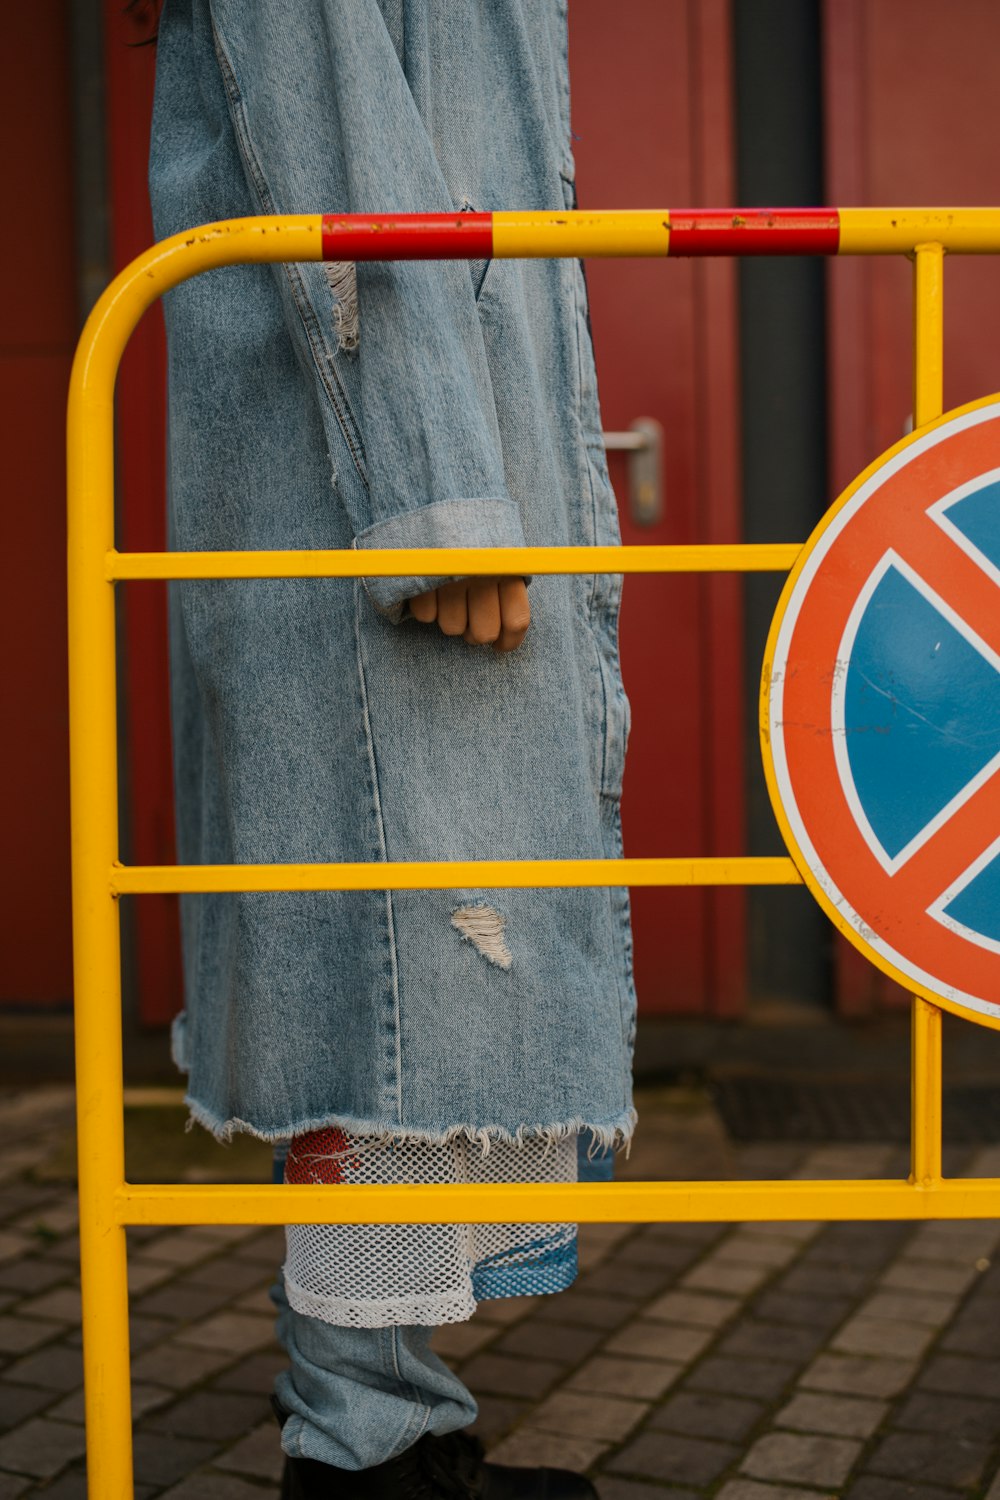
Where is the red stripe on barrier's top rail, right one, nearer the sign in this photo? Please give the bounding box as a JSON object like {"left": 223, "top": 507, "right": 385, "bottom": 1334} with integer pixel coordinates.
{"left": 669, "top": 209, "right": 840, "bottom": 255}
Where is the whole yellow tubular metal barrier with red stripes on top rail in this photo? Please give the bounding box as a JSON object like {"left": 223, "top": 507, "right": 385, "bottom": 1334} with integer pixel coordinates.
{"left": 67, "top": 209, "right": 1000, "bottom": 1500}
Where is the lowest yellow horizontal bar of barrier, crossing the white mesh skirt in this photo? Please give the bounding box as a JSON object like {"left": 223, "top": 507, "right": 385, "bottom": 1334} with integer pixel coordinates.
{"left": 114, "top": 1178, "right": 1000, "bottom": 1224}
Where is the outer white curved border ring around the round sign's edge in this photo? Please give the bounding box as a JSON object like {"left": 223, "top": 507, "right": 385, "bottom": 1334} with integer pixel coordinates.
{"left": 768, "top": 402, "right": 1000, "bottom": 1019}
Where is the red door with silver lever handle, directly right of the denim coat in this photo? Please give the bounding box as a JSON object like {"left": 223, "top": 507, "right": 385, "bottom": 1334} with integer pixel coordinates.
{"left": 570, "top": 0, "right": 747, "bottom": 1016}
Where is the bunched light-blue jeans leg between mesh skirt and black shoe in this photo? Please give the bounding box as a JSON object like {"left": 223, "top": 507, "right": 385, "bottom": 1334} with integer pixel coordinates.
{"left": 271, "top": 1277, "right": 477, "bottom": 1469}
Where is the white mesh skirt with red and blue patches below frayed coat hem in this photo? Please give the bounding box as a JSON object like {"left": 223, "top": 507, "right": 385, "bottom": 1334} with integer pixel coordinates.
{"left": 285, "top": 1127, "right": 577, "bottom": 1328}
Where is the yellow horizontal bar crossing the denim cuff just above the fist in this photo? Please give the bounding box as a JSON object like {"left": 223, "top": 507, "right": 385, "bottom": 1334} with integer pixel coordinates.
{"left": 105, "top": 542, "right": 802, "bottom": 582}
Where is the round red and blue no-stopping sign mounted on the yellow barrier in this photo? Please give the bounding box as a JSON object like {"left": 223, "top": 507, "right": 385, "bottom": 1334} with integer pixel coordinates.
{"left": 762, "top": 396, "right": 1000, "bottom": 1028}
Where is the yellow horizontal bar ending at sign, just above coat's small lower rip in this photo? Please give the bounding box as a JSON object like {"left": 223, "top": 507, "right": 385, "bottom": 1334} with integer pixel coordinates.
{"left": 108, "top": 855, "right": 802, "bottom": 896}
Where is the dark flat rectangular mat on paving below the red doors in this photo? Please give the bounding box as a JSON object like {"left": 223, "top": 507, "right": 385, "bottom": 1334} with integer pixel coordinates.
{"left": 711, "top": 1077, "right": 1000, "bottom": 1145}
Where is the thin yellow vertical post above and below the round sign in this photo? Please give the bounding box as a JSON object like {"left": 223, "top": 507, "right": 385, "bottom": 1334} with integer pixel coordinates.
{"left": 910, "top": 245, "right": 945, "bottom": 1185}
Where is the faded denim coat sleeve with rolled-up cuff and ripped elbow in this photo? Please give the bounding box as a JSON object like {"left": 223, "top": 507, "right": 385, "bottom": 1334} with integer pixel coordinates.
{"left": 210, "top": 0, "right": 525, "bottom": 618}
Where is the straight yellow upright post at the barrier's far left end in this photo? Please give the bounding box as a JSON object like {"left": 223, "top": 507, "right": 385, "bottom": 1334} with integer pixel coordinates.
{"left": 67, "top": 325, "right": 132, "bottom": 1500}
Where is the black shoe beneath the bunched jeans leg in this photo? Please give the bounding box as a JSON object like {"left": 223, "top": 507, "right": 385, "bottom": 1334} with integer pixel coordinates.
{"left": 274, "top": 1403, "right": 597, "bottom": 1500}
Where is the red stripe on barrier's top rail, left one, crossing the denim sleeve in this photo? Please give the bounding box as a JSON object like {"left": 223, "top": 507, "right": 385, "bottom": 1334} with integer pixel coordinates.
{"left": 322, "top": 213, "right": 493, "bottom": 261}
